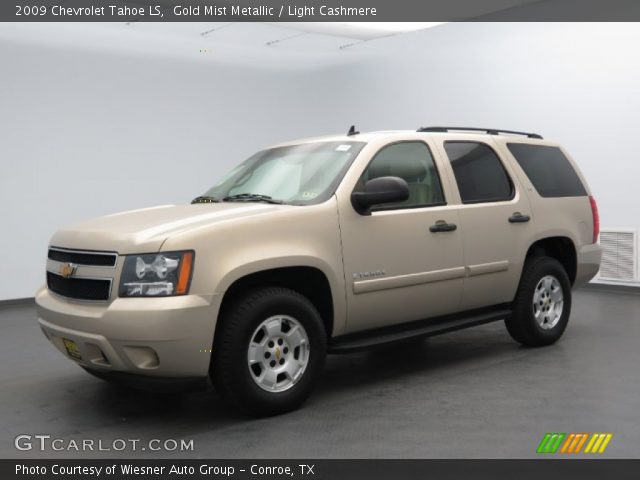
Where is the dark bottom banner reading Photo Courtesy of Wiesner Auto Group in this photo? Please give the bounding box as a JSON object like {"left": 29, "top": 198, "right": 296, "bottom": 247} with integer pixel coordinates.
{"left": 0, "top": 458, "right": 640, "bottom": 480}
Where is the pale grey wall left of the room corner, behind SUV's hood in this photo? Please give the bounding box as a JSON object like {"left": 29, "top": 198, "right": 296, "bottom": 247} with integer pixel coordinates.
{"left": 0, "top": 29, "right": 348, "bottom": 300}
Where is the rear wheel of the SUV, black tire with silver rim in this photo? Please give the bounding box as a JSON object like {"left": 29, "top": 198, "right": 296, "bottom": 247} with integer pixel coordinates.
{"left": 505, "top": 256, "right": 571, "bottom": 347}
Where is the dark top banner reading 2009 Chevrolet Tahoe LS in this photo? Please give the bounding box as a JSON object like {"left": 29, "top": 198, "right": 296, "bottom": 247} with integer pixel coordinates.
{"left": 0, "top": 0, "right": 640, "bottom": 22}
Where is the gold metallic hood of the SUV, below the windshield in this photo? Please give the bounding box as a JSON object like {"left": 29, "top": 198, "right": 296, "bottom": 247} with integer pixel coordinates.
{"left": 51, "top": 202, "right": 294, "bottom": 253}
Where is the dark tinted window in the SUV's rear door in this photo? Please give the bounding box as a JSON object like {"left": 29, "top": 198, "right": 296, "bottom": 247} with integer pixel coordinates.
{"left": 444, "top": 142, "right": 513, "bottom": 203}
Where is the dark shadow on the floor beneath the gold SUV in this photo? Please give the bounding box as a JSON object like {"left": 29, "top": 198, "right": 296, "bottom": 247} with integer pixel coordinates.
{"left": 70, "top": 326, "right": 521, "bottom": 431}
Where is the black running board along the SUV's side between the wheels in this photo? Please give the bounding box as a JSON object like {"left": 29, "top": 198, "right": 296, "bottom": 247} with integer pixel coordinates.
{"left": 328, "top": 306, "right": 512, "bottom": 353}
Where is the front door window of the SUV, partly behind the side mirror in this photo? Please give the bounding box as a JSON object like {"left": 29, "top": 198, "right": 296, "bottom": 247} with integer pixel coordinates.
{"left": 362, "top": 142, "right": 444, "bottom": 209}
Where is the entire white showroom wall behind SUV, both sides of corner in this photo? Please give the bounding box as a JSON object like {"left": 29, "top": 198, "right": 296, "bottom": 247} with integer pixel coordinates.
{"left": 0, "top": 23, "right": 640, "bottom": 300}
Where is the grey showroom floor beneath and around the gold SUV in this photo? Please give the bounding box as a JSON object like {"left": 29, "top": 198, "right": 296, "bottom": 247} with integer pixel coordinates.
{"left": 0, "top": 289, "right": 640, "bottom": 458}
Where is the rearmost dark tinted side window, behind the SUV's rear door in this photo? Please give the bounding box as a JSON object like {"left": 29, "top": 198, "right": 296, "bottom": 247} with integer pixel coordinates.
{"left": 507, "top": 143, "right": 587, "bottom": 197}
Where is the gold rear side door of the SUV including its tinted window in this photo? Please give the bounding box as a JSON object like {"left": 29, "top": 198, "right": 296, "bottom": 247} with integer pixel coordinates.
{"left": 440, "top": 138, "right": 535, "bottom": 310}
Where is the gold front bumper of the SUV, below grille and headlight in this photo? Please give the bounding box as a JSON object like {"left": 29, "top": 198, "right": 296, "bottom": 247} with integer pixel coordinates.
{"left": 36, "top": 287, "right": 221, "bottom": 378}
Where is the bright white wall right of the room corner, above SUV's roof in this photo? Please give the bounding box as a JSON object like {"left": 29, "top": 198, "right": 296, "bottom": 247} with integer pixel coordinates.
{"left": 340, "top": 23, "right": 640, "bottom": 228}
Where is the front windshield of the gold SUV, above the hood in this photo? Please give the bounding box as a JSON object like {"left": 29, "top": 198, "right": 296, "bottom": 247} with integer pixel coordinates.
{"left": 199, "top": 142, "right": 365, "bottom": 205}
